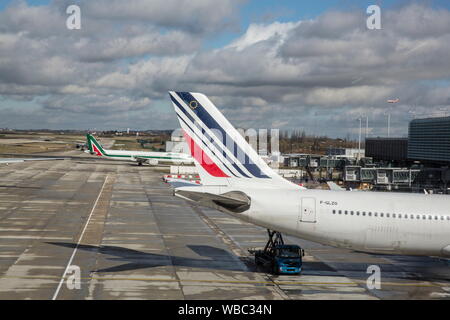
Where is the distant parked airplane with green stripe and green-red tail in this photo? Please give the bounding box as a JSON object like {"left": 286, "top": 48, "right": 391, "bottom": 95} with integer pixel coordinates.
{"left": 86, "top": 133, "right": 193, "bottom": 165}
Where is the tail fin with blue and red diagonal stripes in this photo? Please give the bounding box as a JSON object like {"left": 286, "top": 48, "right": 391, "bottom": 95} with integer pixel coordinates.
{"left": 169, "top": 91, "right": 295, "bottom": 187}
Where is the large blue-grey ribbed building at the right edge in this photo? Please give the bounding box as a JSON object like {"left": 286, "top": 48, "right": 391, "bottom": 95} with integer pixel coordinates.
{"left": 408, "top": 117, "right": 450, "bottom": 164}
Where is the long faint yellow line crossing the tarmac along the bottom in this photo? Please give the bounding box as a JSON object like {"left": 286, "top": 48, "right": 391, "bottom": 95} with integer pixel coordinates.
{"left": 0, "top": 275, "right": 443, "bottom": 289}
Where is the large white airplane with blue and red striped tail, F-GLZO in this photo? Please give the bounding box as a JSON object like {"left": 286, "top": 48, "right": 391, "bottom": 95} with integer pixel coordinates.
{"left": 170, "top": 91, "right": 450, "bottom": 257}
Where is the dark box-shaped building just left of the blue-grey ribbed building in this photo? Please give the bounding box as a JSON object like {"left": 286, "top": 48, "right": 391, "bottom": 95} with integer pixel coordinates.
{"left": 366, "top": 138, "right": 408, "bottom": 161}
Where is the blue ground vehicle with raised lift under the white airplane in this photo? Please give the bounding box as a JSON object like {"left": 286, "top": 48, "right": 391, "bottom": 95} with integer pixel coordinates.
{"left": 250, "top": 230, "right": 304, "bottom": 274}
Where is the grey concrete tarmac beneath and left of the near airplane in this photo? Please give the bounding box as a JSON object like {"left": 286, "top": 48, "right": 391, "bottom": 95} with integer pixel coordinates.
{"left": 0, "top": 151, "right": 450, "bottom": 300}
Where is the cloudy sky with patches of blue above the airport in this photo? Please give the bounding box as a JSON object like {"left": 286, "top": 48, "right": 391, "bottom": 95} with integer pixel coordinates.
{"left": 0, "top": 0, "right": 450, "bottom": 137}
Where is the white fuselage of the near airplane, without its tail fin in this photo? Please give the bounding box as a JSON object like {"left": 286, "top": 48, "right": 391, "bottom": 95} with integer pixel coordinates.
{"left": 207, "top": 187, "right": 450, "bottom": 256}
